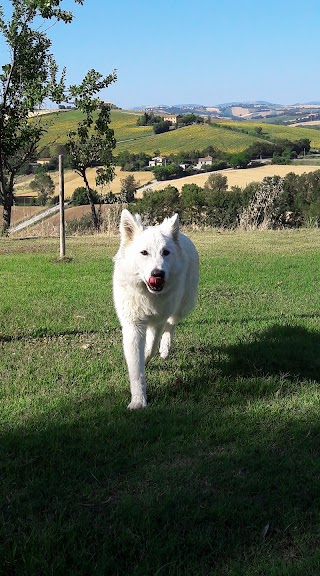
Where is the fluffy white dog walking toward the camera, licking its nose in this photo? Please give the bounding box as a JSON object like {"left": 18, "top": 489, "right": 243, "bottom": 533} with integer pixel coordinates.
{"left": 113, "top": 210, "right": 199, "bottom": 410}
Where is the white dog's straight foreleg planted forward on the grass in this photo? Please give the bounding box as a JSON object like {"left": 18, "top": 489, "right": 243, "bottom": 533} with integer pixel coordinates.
{"left": 122, "top": 324, "right": 147, "bottom": 410}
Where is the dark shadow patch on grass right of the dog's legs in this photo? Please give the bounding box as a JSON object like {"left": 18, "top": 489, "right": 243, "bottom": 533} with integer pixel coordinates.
{"left": 148, "top": 325, "right": 320, "bottom": 406}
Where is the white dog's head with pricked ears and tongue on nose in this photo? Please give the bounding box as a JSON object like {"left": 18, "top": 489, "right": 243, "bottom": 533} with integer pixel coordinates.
{"left": 120, "top": 210, "right": 180, "bottom": 294}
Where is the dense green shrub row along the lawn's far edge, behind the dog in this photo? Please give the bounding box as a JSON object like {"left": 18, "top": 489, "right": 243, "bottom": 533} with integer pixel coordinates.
{"left": 133, "top": 170, "right": 320, "bottom": 228}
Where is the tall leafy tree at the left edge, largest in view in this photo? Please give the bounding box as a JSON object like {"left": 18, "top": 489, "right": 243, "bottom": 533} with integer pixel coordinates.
{"left": 0, "top": 0, "right": 83, "bottom": 233}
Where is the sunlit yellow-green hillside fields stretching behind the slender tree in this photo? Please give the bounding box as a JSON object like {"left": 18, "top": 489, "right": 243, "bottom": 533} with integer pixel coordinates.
{"left": 35, "top": 110, "right": 320, "bottom": 154}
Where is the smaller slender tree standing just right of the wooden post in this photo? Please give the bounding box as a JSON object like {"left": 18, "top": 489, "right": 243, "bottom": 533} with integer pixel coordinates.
{"left": 66, "top": 69, "right": 117, "bottom": 231}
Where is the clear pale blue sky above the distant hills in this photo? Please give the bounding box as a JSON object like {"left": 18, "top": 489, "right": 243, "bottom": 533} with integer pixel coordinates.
{"left": 0, "top": 0, "right": 320, "bottom": 108}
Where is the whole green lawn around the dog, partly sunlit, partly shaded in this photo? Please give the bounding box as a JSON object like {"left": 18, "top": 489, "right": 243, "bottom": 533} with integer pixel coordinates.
{"left": 0, "top": 230, "right": 320, "bottom": 576}
